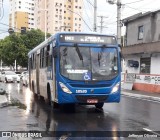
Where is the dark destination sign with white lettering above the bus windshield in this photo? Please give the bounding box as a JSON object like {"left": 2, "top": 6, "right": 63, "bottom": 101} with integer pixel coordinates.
{"left": 60, "top": 34, "right": 116, "bottom": 44}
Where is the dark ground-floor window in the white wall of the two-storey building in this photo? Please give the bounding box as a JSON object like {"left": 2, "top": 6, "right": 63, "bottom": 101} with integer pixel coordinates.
{"left": 140, "top": 57, "right": 151, "bottom": 74}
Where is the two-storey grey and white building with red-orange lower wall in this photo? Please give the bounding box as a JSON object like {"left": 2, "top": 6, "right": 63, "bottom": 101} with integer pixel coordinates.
{"left": 122, "top": 10, "right": 160, "bottom": 93}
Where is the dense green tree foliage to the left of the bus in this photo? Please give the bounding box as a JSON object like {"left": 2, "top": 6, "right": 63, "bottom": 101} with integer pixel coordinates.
{"left": 0, "top": 30, "right": 50, "bottom": 67}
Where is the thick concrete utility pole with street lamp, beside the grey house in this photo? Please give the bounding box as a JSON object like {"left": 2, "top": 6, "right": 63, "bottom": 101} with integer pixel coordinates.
{"left": 107, "top": 0, "right": 122, "bottom": 44}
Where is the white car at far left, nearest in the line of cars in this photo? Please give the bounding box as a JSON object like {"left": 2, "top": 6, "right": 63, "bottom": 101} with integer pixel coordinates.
{"left": 1, "top": 71, "right": 20, "bottom": 83}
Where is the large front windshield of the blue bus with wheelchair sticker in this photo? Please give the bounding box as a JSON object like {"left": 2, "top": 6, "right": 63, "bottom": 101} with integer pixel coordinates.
{"left": 60, "top": 46, "right": 118, "bottom": 81}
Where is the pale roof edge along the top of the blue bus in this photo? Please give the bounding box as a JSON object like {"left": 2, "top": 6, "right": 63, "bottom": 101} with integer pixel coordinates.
{"left": 28, "top": 32, "right": 116, "bottom": 56}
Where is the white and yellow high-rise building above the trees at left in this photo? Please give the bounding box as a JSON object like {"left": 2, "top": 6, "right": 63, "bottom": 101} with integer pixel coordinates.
{"left": 9, "top": 0, "right": 35, "bottom": 32}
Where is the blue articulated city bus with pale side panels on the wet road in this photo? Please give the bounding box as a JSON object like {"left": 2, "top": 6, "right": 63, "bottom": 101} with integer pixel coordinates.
{"left": 28, "top": 32, "right": 121, "bottom": 108}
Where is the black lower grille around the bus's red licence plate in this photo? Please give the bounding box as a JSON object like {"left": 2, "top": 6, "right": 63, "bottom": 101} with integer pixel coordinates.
{"left": 76, "top": 95, "right": 108, "bottom": 103}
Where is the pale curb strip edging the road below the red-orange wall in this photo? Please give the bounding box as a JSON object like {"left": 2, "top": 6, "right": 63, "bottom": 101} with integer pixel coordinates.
{"left": 122, "top": 91, "right": 160, "bottom": 102}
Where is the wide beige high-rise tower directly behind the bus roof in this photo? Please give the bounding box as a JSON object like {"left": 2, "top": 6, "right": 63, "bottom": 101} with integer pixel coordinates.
{"left": 35, "top": 0, "right": 83, "bottom": 34}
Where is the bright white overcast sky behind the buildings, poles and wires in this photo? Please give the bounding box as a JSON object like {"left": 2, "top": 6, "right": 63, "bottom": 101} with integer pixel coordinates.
{"left": 0, "top": 0, "right": 160, "bottom": 39}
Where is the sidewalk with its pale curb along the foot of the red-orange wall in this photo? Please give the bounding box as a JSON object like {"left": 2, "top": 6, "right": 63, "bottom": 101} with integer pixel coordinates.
{"left": 122, "top": 88, "right": 160, "bottom": 102}
